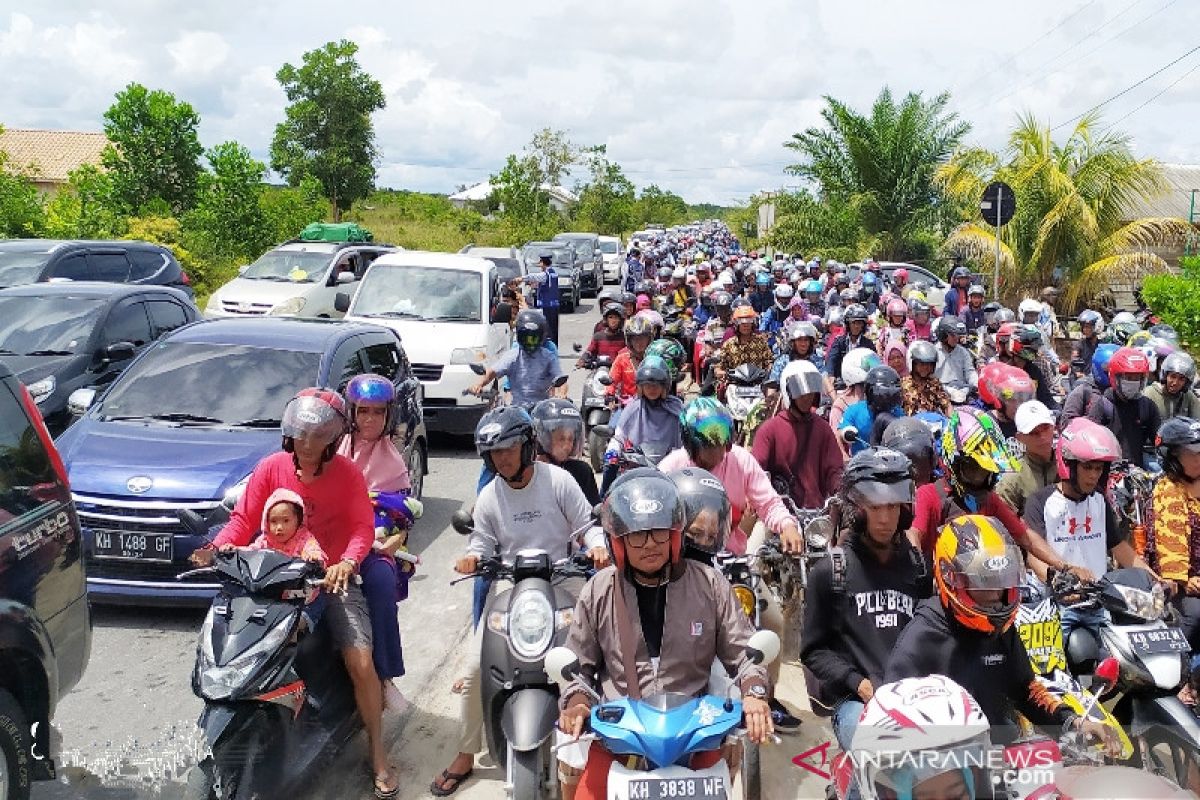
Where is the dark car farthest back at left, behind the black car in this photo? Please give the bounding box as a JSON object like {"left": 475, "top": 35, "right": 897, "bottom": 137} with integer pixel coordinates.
{"left": 0, "top": 239, "right": 192, "bottom": 295}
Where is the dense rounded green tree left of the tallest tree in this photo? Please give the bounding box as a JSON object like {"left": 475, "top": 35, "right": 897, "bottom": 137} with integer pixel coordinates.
{"left": 101, "top": 83, "right": 203, "bottom": 213}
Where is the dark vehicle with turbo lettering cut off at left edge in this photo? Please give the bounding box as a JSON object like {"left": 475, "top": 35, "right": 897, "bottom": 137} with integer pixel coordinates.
{"left": 0, "top": 362, "right": 91, "bottom": 799}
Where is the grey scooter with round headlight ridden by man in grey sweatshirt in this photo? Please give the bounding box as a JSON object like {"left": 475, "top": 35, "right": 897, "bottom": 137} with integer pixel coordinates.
{"left": 451, "top": 511, "right": 592, "bottom": 800}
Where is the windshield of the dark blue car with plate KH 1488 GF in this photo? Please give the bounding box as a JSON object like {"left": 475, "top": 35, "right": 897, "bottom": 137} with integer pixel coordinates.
{"left": 98, "top": 342, "right": 320, "bottom": 427}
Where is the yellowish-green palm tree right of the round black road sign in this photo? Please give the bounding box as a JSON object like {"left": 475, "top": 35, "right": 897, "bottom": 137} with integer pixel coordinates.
{"left": 936, "top": 114, "right": 1190, "bottom": 306}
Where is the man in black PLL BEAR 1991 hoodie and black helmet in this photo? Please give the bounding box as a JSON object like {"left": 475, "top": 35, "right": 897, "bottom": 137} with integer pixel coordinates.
{"left": 800, "top": 447, "right": 931, "bottom": 772}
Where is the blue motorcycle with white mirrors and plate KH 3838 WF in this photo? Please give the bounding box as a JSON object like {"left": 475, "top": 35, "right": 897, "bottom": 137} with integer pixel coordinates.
{"left": 546, "top": 631, "right": 779, "bottom": 800}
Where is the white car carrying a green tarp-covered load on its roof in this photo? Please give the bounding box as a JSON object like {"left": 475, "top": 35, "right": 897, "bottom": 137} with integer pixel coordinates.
{"left": 204, "top": 241, "right": 397, "bottom": 319}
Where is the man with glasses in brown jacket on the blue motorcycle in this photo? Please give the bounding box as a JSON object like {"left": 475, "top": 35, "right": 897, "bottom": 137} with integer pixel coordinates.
{"left": 559, "top": 469, "right": 772, "bottom": 798}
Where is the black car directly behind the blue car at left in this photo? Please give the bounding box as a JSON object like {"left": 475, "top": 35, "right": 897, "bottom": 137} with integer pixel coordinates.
{"left": 0, "top": 282, "right": 200, "bottom": 435}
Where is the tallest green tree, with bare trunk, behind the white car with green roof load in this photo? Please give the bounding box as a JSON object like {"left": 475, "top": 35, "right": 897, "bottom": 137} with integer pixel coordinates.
{"left": 271, "top": 40, "right": 386, "bottom": 221}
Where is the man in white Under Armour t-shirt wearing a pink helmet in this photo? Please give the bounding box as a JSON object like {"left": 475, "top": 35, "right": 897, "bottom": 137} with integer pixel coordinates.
{"left": 1025, "top": 416, "right": 1150, "bottom": 645}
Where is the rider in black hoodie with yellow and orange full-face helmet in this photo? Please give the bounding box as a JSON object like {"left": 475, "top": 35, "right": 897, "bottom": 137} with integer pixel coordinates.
{"left": 884, "top": 515, "right": 1120, "bottom": 754}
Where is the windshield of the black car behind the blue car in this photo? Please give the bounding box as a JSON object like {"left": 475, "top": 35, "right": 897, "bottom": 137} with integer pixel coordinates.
{"left": 0, "top": 294, "right": 104, "bottom": 356}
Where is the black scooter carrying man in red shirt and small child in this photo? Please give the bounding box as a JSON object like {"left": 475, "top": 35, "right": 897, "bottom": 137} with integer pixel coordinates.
{"left": 180, "top": 549, "right": 362, "bottom": 800}
